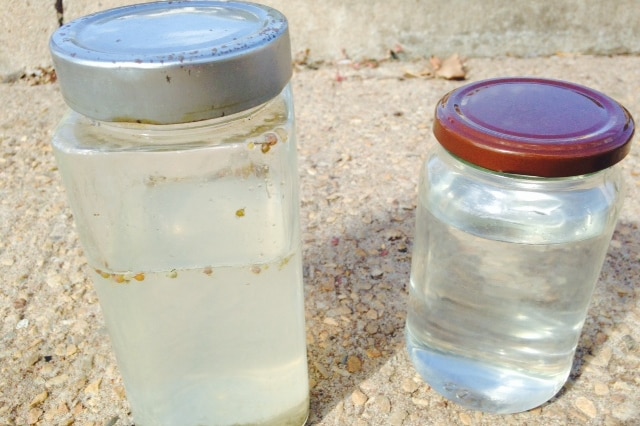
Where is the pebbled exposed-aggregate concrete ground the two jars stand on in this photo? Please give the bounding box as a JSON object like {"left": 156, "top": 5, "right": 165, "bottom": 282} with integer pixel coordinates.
{"left": 0, "top": 56, "right": 640, "bottom": 426}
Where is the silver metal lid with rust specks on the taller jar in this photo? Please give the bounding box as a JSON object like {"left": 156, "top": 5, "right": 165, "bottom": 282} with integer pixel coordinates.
{"left": 50, "top": 0, "right": 292, "bottom": 124}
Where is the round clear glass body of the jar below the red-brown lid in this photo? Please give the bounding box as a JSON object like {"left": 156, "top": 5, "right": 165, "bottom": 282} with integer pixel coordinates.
{"left": 407, "top": 146, "right": 623, "bottom": 413}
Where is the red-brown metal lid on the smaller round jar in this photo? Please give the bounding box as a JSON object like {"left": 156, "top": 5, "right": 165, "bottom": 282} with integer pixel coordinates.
{"left": 433, "top": 78, "right": 635, "bottom": 177}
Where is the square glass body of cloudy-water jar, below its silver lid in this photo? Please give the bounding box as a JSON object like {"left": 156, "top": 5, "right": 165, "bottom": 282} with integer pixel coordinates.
{"left": 53, "top": 86, "right": 308, "bottom": 425}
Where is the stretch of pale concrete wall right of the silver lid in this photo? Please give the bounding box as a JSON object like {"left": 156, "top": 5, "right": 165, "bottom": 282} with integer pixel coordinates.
{"left": 276, "top": 0, "right": 640, "bottom": 58}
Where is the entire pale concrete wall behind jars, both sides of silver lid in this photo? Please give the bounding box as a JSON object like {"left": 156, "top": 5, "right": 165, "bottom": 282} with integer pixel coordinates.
{"left": 0, "top": 0, "right": 640, "bottom": 77}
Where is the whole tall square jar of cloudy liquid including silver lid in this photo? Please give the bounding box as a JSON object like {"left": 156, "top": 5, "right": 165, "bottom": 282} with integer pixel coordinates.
{"left": 51, "top": 1, "right": 309, "bottom": 426}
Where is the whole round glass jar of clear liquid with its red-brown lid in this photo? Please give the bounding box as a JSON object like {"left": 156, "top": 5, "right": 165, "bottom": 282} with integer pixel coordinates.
{"left": 407, "top": 78, "right": 634, "bottom": 413}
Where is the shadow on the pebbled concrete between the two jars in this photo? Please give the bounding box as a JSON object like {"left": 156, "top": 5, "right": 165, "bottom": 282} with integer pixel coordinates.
{"left": 304, "top": 207, "right": 414, "bottom": 424}
